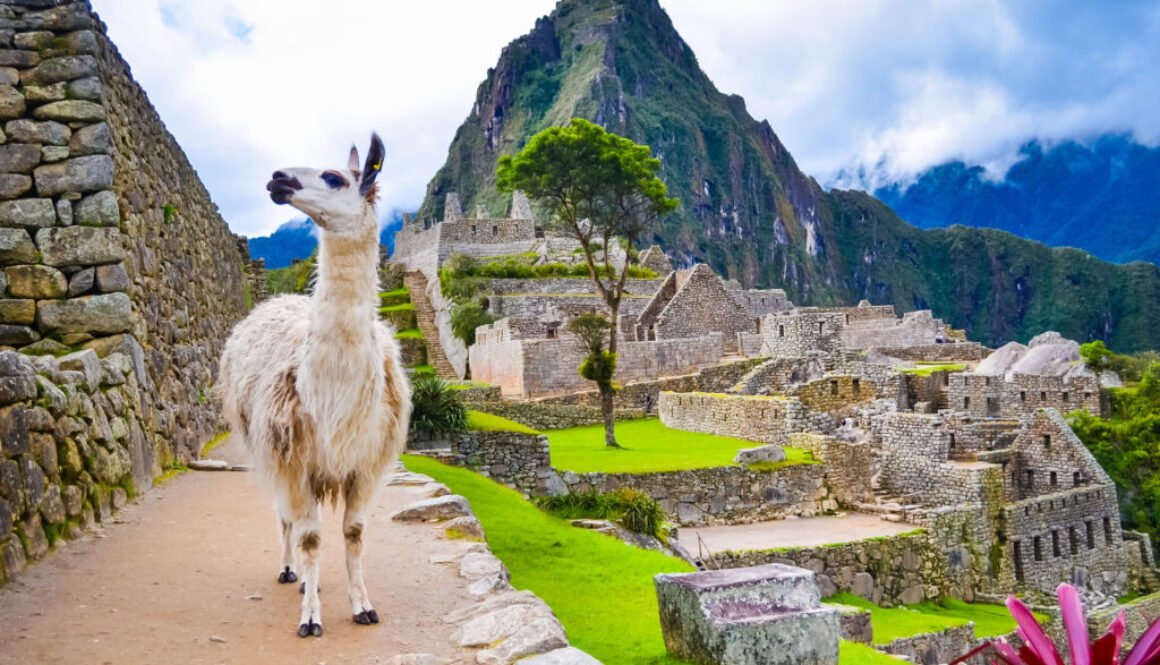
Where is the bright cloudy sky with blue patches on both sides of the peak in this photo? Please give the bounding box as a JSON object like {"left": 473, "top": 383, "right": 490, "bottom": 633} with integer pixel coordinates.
{"left": 92, "top": 0, "right": 1160, "bottom": 236}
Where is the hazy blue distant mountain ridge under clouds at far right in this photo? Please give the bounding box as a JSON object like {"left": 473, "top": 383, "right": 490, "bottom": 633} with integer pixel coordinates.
{"left": 873, "top": 135, "right": 1160, "bottom": 263}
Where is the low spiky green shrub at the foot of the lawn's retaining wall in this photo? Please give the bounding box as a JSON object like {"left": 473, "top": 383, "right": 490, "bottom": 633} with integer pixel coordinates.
{"left": 536, "top": 487, "right": 668, "bottom": 542}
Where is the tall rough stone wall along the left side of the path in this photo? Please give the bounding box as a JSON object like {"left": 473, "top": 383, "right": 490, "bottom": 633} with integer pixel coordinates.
{"left": 0, "top": 0, "right": 244, "bottom": 573}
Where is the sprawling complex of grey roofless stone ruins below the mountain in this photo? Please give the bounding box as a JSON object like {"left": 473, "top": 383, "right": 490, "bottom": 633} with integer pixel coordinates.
{"left": 392, "top": 191, "right": 1160, "bottom": 602}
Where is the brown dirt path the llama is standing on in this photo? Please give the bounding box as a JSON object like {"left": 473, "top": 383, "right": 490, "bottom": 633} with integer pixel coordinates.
{"left": 0, "top": 461, "right": 474, "bottom": 665}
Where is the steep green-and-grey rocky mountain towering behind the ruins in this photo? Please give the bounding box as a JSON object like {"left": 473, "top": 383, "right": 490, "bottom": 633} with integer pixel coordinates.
{"left": 419, "top": 0, "right": 1160, "bottom": 349}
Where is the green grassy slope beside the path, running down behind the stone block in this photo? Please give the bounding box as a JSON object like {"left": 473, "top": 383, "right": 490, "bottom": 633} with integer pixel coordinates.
{"left": 404, "top": 455, "right": 899, "bottom": 665}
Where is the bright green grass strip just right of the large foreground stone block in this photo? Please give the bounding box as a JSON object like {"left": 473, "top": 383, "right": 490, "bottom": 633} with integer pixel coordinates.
{"left": 826, "top": 593, "right": 1047, "bottom": 644}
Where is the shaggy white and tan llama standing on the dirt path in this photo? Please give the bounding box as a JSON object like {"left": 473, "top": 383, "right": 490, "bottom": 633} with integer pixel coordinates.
{"left": 219, "top": 135, "right": 411, "bottom": 637}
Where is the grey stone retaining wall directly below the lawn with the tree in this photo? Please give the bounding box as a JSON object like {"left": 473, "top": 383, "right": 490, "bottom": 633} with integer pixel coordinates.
{"left": 559, "top": 464, "right": 838, "bottom": 527}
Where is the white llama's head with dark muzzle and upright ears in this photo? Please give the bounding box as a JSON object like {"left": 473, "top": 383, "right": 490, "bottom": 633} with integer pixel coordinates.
{"left": 266, "top": 133, "right": 385, "bottom": 236}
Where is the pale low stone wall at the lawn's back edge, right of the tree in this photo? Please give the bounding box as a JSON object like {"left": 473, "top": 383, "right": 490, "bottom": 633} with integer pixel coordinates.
{"left": 657, "top": 392, "right": 833, "bottom": 444}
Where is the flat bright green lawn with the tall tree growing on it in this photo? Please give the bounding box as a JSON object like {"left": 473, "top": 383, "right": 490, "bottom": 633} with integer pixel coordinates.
{"left": 546, "top": 418, "right": 815, "bottom": 474}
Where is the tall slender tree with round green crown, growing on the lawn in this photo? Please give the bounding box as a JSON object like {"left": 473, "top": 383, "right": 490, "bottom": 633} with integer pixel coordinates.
{"left": 496, "top": 118, "right": 677, "bottom": 446}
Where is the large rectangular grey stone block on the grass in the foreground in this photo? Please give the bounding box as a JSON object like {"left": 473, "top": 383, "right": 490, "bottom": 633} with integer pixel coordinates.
{"left": 655, "top": 564, "right": 841, "bottom": 665}
